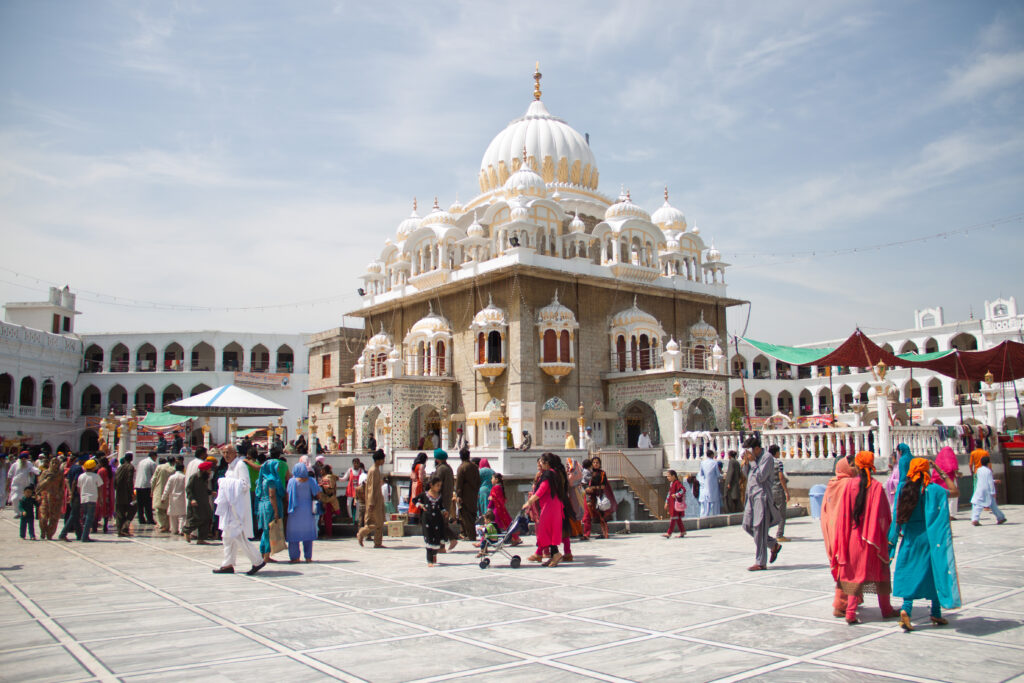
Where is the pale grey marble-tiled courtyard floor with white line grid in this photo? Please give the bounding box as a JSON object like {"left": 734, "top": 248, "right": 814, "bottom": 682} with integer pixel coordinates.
{"left": 0, "top": 507, "right": 1024, "bottom": 683}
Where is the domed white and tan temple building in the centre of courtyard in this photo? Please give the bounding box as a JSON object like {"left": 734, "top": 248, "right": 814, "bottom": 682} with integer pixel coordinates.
{"left": 348, "top": 73, "right": 741, "bottom": 451}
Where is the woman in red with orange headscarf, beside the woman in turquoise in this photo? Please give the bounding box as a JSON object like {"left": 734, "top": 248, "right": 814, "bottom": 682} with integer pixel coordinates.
{"left": 829, "top": 451, "right": 897, "bottom": 625}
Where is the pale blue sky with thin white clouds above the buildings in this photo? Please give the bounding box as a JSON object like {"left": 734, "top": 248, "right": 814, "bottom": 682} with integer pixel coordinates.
{"left": 0, "top": 0, "right": 1024, "bottom": 343}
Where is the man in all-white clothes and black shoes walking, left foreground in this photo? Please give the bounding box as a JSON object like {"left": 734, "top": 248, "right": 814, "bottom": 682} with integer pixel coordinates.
{"left": 213, "top": 446, "right": 266, "bottom": 575}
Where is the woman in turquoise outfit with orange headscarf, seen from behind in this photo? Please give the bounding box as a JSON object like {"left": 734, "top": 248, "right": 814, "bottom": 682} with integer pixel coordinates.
{"left": 889, "top": 454, "right": 961, "bottom": 631}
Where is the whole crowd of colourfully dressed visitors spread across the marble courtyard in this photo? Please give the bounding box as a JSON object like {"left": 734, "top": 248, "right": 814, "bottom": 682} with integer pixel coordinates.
{"left": 0, "top": 436, "right": 1006, "bottom": 614}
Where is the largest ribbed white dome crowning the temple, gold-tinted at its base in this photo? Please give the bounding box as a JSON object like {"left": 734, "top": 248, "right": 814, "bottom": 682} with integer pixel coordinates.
{"left": 480, "top": 99, "right": 598, "bottom": 193}
